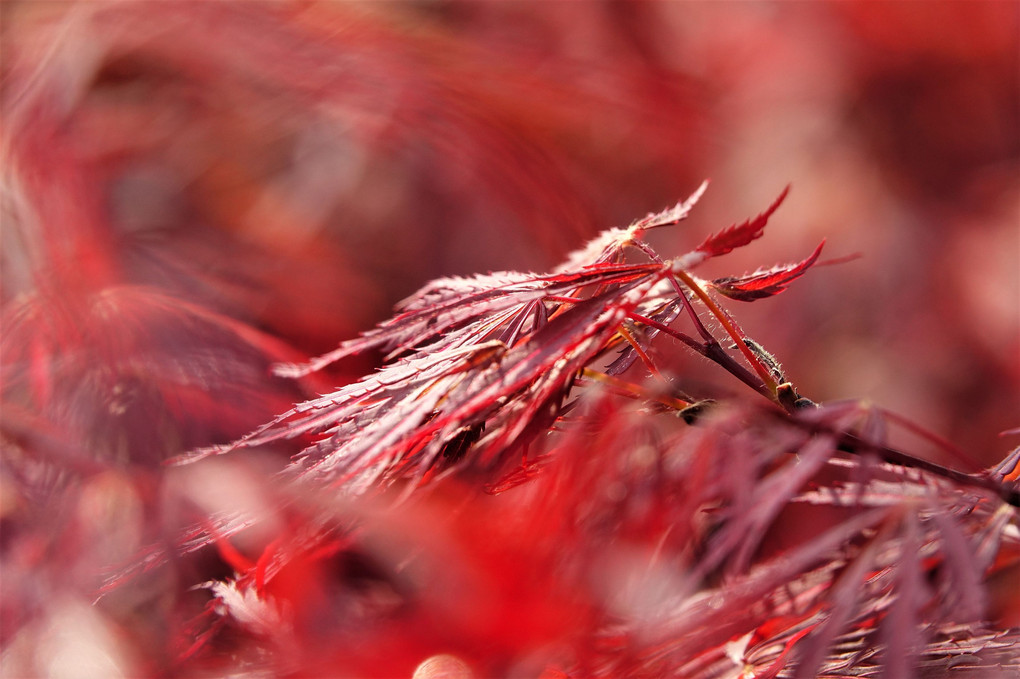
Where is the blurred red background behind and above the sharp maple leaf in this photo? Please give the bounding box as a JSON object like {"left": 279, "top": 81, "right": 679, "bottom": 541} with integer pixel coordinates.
{"left": 0, "top": 0, "right": 1020, "bottom": 672}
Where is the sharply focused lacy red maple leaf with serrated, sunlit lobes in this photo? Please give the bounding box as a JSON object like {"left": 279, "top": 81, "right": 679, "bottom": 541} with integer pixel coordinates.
{"left": 177, "top": 185, "right": 818, "bottom": 492}
